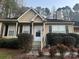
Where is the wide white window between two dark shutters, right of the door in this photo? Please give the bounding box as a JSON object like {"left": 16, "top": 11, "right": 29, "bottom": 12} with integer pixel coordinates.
{"left": 52, "top": 25, "right": 66, "bottom": 33}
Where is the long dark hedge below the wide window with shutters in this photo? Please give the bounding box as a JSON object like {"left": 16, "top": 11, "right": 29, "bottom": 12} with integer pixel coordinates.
{"left": 46, "top": 33, "right": 79, "bottom": 47}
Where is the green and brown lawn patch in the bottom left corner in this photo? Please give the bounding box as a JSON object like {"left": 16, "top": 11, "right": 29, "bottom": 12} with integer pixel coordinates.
{"left": 0, "top": 49, "right": 19, "bottom": 59}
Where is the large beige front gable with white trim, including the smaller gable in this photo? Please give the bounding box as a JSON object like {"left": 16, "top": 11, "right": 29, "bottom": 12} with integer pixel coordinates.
{"left": 18, "top": 9, "right": 42, "bottom": 22}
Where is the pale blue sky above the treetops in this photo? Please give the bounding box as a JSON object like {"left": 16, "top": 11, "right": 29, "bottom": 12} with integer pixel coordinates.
{"left": 23, "top": 0, "right": 79, "bottom": 9}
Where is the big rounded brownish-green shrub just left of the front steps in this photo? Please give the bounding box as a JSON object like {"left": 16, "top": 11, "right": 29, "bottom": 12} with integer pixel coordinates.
{"left": 18, "top": 33, "right": 33, "bottom": 53}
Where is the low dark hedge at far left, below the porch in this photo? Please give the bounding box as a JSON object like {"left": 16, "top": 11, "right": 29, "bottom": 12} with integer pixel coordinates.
{"left": 0, "top": 38, "right": 19, "bottom": 49}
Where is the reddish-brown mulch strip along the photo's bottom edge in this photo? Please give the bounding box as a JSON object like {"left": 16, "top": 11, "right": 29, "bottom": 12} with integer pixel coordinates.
{"left": 12, "top": 54, "right": 79, "bottom": 59}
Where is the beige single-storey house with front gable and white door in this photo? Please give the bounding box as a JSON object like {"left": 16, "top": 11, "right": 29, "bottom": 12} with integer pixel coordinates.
{"left": 0, "top": 9, "right": 79, "bottom": 48}
